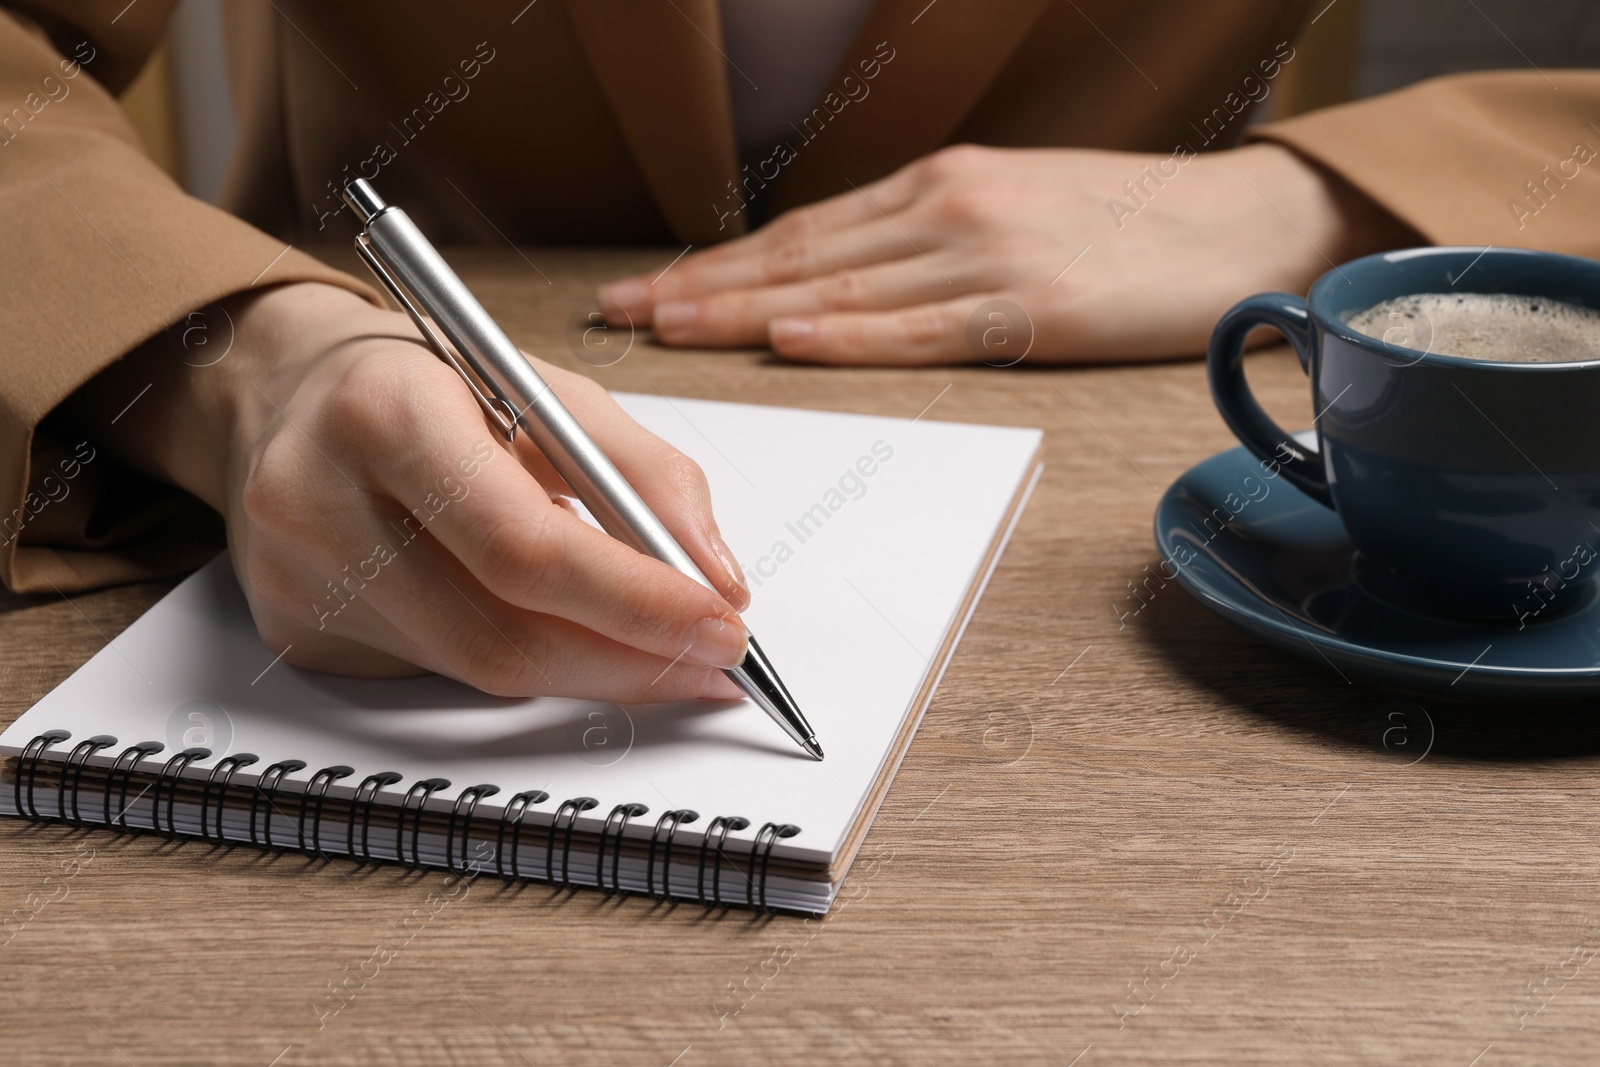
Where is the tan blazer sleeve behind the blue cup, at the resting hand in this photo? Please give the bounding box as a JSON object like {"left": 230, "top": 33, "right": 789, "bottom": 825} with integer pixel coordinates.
{"left": 1250, "top": 70, "right": 1600, "bottom": 256}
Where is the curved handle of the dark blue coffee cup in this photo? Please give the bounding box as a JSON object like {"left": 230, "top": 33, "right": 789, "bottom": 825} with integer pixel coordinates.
{"left": 1205, "top": 293, "right": 1333, "bottom": 507}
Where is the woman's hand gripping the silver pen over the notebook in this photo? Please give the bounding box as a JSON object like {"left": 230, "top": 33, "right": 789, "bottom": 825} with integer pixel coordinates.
{"left": 75, "top": 285, "right": 749, "bottom": 702}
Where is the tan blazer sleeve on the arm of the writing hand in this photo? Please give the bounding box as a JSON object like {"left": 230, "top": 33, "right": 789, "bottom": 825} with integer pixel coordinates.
{"left": 0, "top": 0, "right": 378, "bottom": 593}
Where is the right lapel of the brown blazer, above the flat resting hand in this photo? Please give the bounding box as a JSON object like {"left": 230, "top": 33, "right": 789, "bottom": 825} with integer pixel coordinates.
{"left": 773, "top": 0, "right": 1050, "bottom": 210}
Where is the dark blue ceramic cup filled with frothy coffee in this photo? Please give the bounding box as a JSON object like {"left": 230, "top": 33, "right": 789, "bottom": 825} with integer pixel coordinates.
{"left": 1206, "top": 248, "right": 1600, "bottom": 629}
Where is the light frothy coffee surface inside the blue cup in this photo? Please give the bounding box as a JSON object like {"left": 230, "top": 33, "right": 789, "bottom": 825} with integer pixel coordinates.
{"left": 1346, "top": 293, "right": 1600, "bottom": 363}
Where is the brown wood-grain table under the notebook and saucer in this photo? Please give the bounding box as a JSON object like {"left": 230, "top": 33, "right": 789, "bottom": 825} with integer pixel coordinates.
{"left": 0, "top": 251, "right": 1600, "bottom": 1067}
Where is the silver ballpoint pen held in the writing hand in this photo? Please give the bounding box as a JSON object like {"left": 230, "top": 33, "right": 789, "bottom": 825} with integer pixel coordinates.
{"left": 344, "top": 178, "right": 822, "bottom": 760}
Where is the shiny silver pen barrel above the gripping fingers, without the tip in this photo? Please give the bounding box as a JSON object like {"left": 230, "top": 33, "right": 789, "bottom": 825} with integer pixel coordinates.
{"left": 366, "top": 206, "right": 714, "bottom": 589}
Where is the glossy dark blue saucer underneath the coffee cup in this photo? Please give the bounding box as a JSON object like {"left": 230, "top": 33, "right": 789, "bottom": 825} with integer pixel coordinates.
{"left": 1155, "top": 442, "right": 1600, "bottom": 697}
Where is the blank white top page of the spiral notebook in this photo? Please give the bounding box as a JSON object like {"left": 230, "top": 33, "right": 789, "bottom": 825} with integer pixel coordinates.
{"left": 0, "top": 395, "right": 1040, "bottom": 862}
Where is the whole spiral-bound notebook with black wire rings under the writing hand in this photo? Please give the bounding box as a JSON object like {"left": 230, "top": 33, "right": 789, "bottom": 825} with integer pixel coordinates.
{"left": 0, "top": 395, "right": 1042, "bottom": 912}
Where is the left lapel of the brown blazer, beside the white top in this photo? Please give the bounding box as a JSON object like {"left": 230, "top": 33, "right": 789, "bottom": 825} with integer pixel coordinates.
{"left": 555, "top": 0, "right": 746, "bottom": 245}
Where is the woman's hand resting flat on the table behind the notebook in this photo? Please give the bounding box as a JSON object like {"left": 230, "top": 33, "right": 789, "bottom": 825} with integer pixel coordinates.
{"left": 600, "top": 144, "right": 1421, "bottom": 365}
